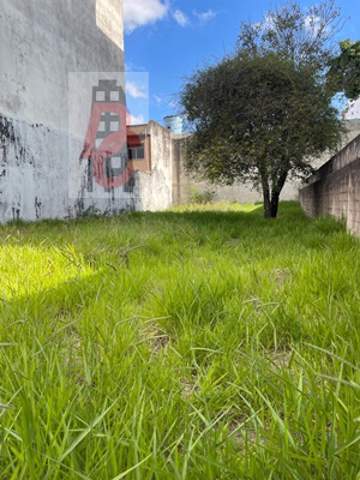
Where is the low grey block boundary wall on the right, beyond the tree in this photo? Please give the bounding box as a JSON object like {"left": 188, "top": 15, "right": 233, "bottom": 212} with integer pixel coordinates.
{"left": 300, "top": 135, "right": 360, "bottom": 235}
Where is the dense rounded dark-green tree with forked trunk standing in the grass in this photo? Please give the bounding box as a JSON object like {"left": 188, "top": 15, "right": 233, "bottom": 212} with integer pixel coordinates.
{"left": 182, "top": 53, "right": 340, "bottom": 217}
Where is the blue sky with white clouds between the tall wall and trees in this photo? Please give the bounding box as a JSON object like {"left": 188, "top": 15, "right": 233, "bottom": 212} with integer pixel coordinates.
{"left": 124, "top": 0, "right": 360, "bottom": 123}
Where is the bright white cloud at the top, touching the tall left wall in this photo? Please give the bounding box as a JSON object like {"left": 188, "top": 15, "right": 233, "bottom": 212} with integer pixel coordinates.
{"left": 124, "top": 0, "right": 169, "bottom": 33}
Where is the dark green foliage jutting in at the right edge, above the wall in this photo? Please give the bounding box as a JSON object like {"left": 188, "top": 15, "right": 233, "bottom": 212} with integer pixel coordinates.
{"left": 328, "top": 40, "right": 360, "bottom": 100}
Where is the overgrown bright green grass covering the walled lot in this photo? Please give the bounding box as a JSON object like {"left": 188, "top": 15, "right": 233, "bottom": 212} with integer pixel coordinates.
{"left": 0, "top": 203, "right": 360, "bottom": 480}
